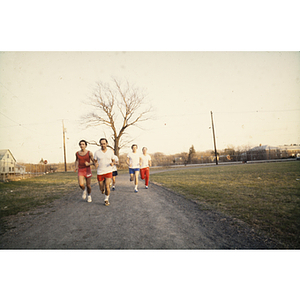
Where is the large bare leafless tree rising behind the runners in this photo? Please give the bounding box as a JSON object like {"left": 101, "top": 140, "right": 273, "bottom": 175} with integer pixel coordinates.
{"left": 82, "top": 78, "right": 152, "bottom": 156}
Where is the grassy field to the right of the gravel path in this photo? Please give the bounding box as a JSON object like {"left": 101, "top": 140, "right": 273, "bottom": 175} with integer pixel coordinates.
{"left": 151, "top": 161, "right": 300, "bottom": 249}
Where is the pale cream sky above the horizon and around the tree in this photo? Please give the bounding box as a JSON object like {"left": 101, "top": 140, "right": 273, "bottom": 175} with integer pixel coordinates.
{"left": 0, "top": 51, "right": 300, "bottom": 163}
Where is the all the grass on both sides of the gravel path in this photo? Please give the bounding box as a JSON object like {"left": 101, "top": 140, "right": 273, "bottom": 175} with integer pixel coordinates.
{"left": 0, "top": 161, "right": 300, "bottom": 249}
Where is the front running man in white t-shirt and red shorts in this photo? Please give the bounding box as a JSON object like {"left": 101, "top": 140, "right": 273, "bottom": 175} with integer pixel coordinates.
{"left": 94, "top": 138, "right": 115, "bottom": 206}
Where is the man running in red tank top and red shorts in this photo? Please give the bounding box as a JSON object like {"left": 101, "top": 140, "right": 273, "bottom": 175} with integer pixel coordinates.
{"left": 75, "top": 140, "right": 94, "bottom": 202}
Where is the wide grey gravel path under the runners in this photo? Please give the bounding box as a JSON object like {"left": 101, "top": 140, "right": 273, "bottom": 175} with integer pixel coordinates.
{"left": 0, "top": 174, "right": 278, "bottom": 249}
